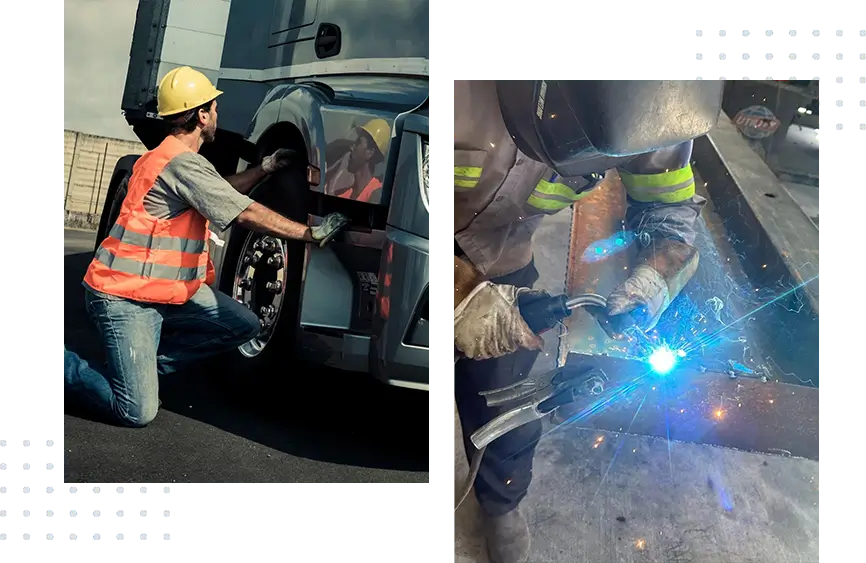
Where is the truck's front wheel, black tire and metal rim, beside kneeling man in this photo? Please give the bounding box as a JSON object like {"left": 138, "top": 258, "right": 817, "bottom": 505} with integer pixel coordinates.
{"left": 221, "top": 161, "right": 307, "bottom": 369}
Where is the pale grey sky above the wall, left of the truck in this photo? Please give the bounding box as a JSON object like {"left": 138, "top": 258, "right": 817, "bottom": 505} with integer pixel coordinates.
{"left": 63, "top": 0, "right": 138, "bottom": 141}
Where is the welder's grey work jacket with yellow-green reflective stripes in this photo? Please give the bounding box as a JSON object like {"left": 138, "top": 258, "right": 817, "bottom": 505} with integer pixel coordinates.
{"left": 450, "top": 80, "right": 705, "bottom": 278}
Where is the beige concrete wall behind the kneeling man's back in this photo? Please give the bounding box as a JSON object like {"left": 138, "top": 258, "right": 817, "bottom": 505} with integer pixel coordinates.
{"left": 63, "top": 131, "right": 146, "bottom": 228}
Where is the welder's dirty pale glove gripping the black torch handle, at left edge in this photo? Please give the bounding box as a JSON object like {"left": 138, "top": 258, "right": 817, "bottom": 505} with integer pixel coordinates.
{"left": 454, "top": 281, "right": 544, "bottom": 360}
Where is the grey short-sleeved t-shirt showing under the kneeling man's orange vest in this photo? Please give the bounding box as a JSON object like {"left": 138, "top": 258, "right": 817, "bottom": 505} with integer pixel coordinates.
{"left": 144, "top": 152, "right": 253, "bottom": 231}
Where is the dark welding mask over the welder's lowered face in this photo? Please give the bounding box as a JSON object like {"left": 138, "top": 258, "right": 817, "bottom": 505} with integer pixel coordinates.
{"left": 496, "top": 80, "right": 724, "bottom": 177}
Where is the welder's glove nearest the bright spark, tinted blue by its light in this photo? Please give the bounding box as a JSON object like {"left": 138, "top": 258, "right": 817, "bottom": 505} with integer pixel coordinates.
{"left": 607, "top": 239, "right": 700, "bottom": 331}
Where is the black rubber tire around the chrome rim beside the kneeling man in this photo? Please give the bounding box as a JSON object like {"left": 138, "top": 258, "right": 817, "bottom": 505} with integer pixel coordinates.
{"left": 219, "top": 158, "right": 309, "bottom": 375}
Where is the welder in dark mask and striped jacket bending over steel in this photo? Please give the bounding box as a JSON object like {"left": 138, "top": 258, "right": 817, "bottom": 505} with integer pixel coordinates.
{"left": 452, "top": 81, "right": 718, "bottom": 563}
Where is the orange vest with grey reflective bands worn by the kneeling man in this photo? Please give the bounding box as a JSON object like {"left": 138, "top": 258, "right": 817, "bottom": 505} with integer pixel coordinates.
{"left": 84, "top": 136, "right": 215, "bottom": 305}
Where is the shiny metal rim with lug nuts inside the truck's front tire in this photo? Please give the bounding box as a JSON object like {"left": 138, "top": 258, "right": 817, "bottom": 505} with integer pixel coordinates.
{"left": 232, "top": 233, "right": 287, "bottom": 358}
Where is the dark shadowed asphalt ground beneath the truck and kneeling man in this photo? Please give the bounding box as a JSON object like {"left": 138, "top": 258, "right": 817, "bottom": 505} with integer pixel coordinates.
{"left": 64, "top": 230, "right": 432, "bottom": 487}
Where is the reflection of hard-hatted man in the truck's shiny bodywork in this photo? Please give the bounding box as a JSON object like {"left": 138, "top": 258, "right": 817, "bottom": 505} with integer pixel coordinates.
{"left": 335, "top": 118, "right": 391, "bottom": 202}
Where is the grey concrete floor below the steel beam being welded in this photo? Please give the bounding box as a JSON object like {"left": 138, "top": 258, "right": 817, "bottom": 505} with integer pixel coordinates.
{"left": 451, "top": 403, "right": 824, "bottom": 563}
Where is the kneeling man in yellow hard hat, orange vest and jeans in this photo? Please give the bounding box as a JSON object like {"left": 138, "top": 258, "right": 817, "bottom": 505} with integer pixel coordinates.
{"left": 64, "top": 67, "right": 347, "bottom": 426}
